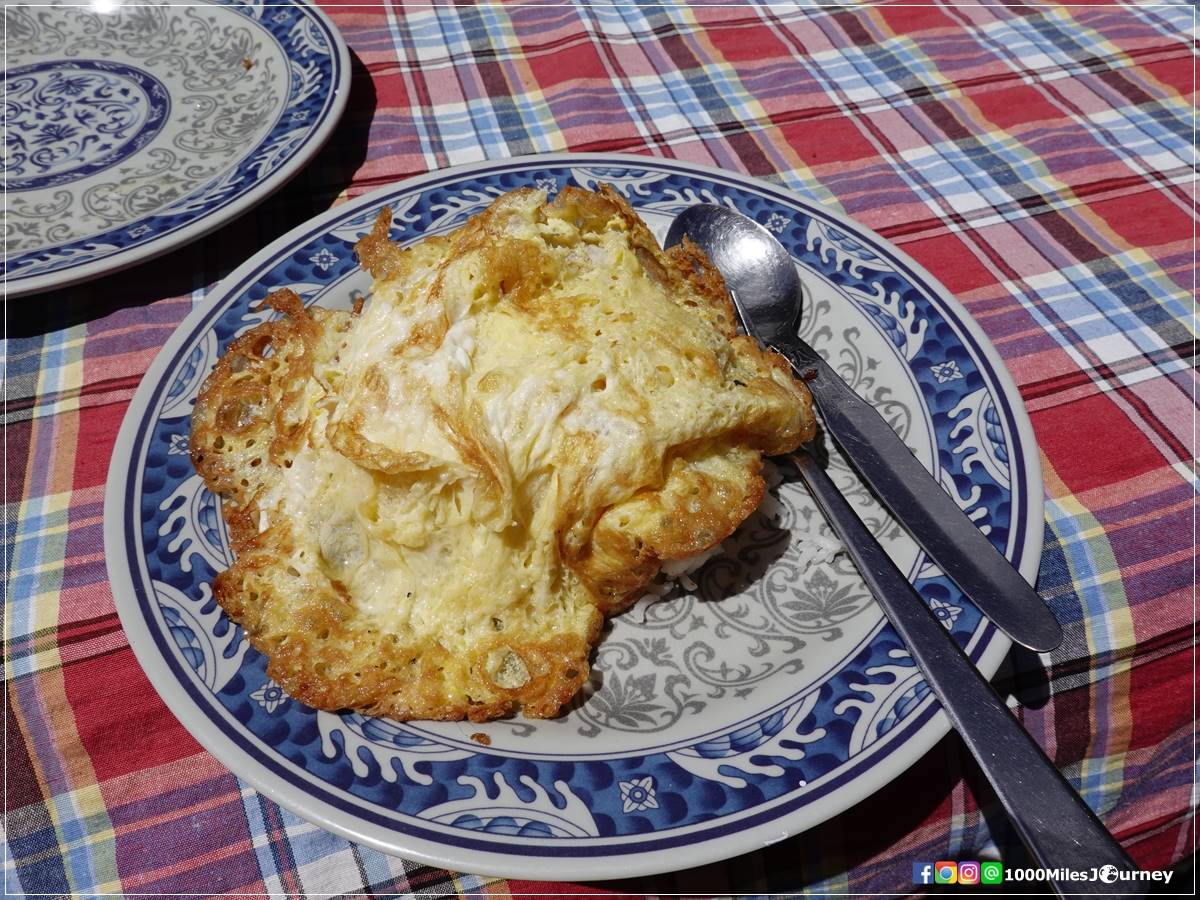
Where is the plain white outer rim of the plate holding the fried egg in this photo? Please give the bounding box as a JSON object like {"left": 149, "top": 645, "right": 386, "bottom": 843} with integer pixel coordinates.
{"left": 103, "top": 154, "right": 1044, "bottom": 881}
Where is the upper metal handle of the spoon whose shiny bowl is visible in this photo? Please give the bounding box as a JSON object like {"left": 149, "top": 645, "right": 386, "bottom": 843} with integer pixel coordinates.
{"left": 775, "top": 337, "right": 1062, "bottom": 652}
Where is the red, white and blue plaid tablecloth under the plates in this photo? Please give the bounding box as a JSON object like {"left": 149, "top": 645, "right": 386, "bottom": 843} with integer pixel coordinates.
{"left": 4, "top": 0, "right": 1196, "bottom": 895}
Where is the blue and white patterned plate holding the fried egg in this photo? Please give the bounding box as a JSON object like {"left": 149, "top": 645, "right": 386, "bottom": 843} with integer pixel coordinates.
{"left": 104, "top": 155, "right": 1042, "bottom": 880}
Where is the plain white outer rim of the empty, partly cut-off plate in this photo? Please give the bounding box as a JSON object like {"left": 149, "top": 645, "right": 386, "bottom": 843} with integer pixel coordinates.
{"left": 4, "top": 0, "right": 350, "bottom": 300}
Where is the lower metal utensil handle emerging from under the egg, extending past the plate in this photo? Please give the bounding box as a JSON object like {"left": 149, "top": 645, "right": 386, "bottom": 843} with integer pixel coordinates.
{"left": 792, "top": 451, "right": 1138, "bottom": 896}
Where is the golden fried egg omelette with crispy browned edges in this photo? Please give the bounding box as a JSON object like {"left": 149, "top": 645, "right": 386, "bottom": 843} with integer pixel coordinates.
{"left": 191, "top": 187, "right": 814, "bottom": 721}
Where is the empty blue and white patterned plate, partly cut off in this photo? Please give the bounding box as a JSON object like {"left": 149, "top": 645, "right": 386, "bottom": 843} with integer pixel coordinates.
{"left": 0, "top": 0, "right": 350, "bottom": 296}
